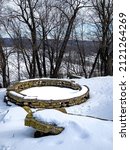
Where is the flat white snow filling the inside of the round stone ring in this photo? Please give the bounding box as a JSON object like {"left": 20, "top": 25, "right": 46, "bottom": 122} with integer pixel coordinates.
{"left": 20, "top": 86, "right": 88, "bottom": 100}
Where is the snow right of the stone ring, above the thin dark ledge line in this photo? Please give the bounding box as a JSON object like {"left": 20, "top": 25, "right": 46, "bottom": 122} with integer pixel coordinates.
{"left": 67, "top": 76, "right": 113, "bottom": 120}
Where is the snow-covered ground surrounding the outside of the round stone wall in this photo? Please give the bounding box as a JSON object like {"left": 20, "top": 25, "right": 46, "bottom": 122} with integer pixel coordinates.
{"left": 0, "top": 77, "right": 113, "bottom": 150}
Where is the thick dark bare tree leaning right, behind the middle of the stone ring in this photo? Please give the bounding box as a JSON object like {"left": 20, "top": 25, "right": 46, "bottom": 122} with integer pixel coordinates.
{"left": 44, "top": 0, "right": 88, "bottom": 77}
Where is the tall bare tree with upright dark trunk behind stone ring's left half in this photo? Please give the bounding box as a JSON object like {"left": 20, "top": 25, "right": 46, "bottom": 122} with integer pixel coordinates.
{"left": 9, "top": 0, "right": 42, "bottom": 78}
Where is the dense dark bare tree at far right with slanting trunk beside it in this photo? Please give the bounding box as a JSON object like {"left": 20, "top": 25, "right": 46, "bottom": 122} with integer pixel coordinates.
{"left": 90, "top": 0, "right": 113, "bottom": 76}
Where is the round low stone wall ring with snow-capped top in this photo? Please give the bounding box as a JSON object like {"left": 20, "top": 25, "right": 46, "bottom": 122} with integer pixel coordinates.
{"left": 7, "top": 79, "right": 89, "bottom": 108}
